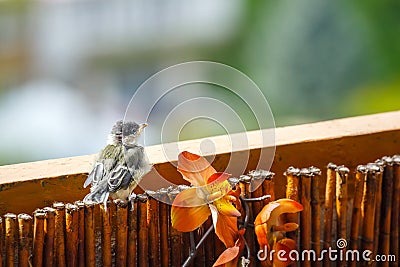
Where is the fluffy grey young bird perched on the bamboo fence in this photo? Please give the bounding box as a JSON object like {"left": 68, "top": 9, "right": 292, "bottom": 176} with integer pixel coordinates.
{"left": 83, "top": 120, "right": 151, "bottom": 206}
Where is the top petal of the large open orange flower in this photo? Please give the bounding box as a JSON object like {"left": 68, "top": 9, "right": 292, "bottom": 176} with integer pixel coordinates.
{"left": 178, "top": 151, "right": 216, "bottom": 186}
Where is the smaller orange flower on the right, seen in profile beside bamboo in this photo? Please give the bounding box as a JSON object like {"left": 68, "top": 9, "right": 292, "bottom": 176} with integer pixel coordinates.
{"left": 254, "top": 199, "right": 303, "bottom": 266}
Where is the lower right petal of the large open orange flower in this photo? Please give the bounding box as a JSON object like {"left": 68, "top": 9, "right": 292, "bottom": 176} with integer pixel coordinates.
{"left": 209, "top": 204, "right": 238, "bottom": 248}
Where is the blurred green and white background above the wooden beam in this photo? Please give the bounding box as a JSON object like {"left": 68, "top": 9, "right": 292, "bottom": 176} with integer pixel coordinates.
{"left": 0, "top": 0, "right": 400, "bottom": 165}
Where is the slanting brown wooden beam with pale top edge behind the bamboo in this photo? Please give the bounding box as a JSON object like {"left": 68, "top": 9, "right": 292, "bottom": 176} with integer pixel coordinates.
{"left": 0, "top": 111, "right": 400, "bottom": 215}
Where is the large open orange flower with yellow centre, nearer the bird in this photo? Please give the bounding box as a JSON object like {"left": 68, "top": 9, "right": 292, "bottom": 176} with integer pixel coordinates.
{"left": 171, "top": 151, "right": 241, "bottom": 247}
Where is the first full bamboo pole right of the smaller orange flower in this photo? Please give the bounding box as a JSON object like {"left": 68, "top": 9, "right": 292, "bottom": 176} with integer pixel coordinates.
{"left": 299, "top": 168, "right": 312, "bottom": 267}
